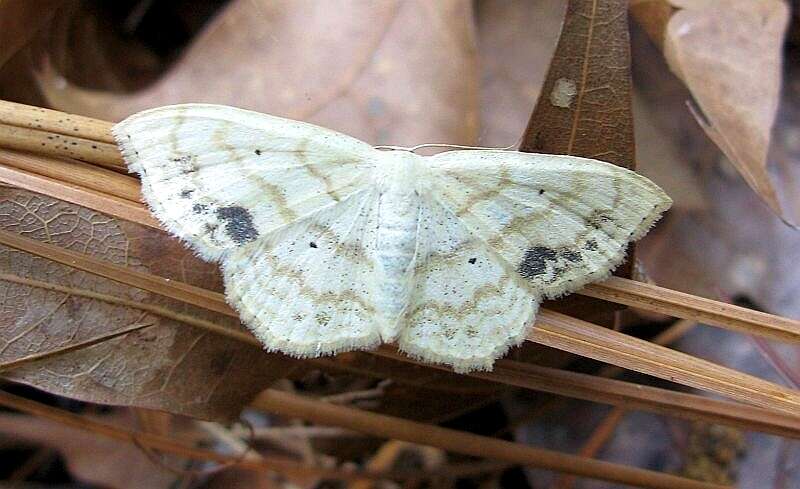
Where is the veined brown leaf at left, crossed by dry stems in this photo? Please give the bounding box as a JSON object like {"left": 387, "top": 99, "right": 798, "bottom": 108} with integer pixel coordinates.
{"left": 0, "top": 187, "right": 293, "bottom": 418}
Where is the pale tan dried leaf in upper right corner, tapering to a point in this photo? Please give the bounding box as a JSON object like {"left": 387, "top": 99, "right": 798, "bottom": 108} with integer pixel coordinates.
{"left": 664, "top": 0, "right": 789, "bottom": 219}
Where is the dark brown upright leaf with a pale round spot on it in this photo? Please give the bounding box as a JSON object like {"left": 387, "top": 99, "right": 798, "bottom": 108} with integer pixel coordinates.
{"left": 520, "top": 0, "right": 635, "bottom": 168}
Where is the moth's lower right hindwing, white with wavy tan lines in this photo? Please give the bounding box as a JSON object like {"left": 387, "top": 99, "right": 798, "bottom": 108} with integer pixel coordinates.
{"left": 397, "top": 195, "right": 540, "bottom": 372}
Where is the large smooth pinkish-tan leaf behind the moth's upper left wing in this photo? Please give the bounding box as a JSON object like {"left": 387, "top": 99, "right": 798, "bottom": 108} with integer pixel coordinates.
{"left": 34, "top": 0, "right": 477, "bottom": 145}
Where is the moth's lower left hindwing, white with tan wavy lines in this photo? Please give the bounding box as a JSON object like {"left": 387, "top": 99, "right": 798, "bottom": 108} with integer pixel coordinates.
{"left": 222, "top": 189, "right": 381, "bottom": 357}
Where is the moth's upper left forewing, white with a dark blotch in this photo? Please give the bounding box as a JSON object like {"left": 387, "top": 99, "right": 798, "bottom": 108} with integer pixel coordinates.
{"left": 113, "top": 104, "right": 377, "bottom": 259}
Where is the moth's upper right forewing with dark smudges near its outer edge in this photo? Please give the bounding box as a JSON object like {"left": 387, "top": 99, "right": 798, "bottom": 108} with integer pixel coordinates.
{"left": 430, "top": 150, "right": 671, "bottom": 298}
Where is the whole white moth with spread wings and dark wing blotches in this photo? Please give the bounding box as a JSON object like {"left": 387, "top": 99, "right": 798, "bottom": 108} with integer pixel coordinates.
{"left": 113, "top": 104, "right": 671, "bottom": 372}
